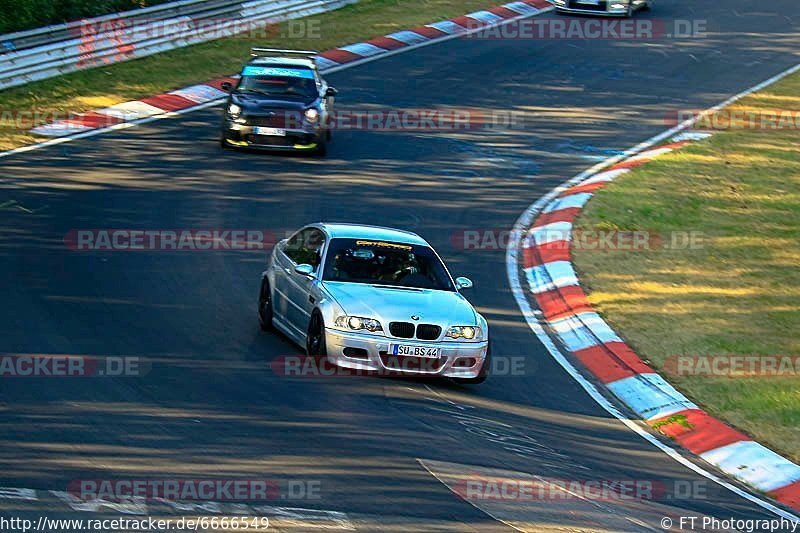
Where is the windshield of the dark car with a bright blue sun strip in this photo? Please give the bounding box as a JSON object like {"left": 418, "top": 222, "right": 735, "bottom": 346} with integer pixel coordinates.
{"left": 236, "top": 65, "right": 317, "bottom": 100}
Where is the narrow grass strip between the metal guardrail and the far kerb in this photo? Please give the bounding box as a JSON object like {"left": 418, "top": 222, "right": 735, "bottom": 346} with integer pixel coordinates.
{"left": 0, "top": 0, "right": 502, "bottom": 150}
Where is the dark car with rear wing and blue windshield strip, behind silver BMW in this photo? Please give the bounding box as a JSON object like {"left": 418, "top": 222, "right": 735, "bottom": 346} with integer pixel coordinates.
{"left": 220, "top": 48, "right": 336, "bottom": 155}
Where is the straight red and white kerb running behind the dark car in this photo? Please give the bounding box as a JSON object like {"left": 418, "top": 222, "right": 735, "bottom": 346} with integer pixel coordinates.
{"left": 29, "top": 0, "right": 553, "bottom": 139}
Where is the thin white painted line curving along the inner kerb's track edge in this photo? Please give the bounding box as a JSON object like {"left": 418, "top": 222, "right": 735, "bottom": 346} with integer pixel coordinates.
{"left": 506, "top": 59, "right": 800, "bottom": 521}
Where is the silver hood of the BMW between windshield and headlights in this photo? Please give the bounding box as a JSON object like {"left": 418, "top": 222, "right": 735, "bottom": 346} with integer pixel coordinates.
{"left": 323, "top": 281, "right": 477, "bottom": 328}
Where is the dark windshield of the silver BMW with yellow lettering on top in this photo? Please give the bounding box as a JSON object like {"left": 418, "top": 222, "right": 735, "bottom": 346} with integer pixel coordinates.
{"left": 323, "top": 239, "right": 455, "bottom": 291}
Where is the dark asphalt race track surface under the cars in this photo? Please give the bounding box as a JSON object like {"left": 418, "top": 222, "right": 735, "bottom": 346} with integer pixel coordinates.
{"left": 0, "top": 0, "right": 800, "bottom": 531}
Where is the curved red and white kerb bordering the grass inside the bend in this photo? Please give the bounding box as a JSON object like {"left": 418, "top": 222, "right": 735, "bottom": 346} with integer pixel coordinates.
{"left": 520, "top": 133, "right": 800, "bottom": 509}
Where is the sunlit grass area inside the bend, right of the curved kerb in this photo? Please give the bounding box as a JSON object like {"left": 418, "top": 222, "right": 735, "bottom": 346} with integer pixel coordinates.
{"left": 574, "top": 71, "right": 800, "bottom": 461}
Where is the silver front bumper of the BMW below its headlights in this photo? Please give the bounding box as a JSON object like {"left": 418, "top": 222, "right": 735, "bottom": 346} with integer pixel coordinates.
{"left": 325, "top": 328, "right": 489, "bottom": 378}
